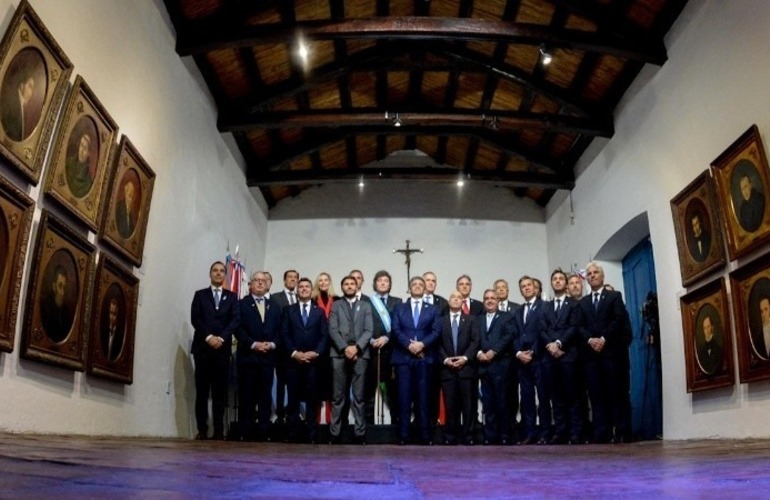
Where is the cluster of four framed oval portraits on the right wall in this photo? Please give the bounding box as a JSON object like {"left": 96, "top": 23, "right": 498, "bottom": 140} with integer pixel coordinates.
{"left": 671, "top": 125, "right": 770, "bottom": 392}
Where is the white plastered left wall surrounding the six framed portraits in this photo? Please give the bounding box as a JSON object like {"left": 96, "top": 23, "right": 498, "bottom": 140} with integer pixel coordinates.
{"left": 0, "top": 0, "right": 267, "bottom": 437}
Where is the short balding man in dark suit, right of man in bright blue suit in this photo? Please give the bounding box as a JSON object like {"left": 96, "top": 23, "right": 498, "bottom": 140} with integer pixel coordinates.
{"left": 439, "top": 290, "right": 479, "bottom": 445}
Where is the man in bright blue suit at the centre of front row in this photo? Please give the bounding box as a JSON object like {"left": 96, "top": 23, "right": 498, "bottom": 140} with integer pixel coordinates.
{"left": 392, "top": 276, "right": 441, "bottom": 445}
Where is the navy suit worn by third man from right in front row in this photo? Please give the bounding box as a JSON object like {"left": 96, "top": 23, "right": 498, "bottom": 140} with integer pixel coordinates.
{"left": 513, "top": 298, "right": 551, "bottom": 441}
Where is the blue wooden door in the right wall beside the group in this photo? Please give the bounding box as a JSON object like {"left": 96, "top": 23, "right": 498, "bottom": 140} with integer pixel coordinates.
{"left": 623, "top": 237, "right": 663, "bottom": 439}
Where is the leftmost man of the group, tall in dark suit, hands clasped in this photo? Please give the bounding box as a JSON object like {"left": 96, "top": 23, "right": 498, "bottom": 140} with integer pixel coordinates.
{"left": 189, "top": 261, "right": 238, "bottom": 439}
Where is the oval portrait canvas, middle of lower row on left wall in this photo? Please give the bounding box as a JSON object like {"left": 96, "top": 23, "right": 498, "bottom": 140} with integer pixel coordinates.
{"left": 40, "top": 249, "right": 78, "bottom": 343}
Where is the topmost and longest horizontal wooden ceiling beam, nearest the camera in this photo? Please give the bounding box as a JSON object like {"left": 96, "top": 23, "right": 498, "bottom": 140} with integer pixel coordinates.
{"left": 176, "top": 17, "right": 667, "bottom": 65}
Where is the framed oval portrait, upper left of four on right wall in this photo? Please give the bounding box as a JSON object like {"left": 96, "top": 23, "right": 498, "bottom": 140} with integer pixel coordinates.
{"left": 671, "top": 170, "right": 726, "bottom": 286}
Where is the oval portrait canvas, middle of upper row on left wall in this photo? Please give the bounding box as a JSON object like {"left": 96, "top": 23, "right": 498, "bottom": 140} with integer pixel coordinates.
{"left": 65, "top": 117, "right": 99, "bottom": 198}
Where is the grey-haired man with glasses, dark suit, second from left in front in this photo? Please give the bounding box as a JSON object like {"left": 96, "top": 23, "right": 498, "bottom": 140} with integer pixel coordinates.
{"left": 235, "top": 271, "right": 281, "bottom": 441}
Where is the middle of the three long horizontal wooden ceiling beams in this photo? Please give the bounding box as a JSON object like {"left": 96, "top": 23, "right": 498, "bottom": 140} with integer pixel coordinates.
{"left": 217, "top": 108, "right": 614, "bottom": 137}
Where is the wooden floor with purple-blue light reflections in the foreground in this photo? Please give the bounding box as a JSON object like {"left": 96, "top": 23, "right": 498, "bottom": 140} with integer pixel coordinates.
{"left": 0, "top": 434, "right": 770, "bottom": 500}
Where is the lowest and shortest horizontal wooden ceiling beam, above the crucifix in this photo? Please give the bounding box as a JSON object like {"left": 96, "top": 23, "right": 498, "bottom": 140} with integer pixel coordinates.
{"left": 246, "top": 167, "right": 575, "bottom": 189}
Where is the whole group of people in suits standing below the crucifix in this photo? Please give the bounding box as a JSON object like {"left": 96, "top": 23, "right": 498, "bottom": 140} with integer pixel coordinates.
{"left": 192, "top": 263, "right": 630, "bottom": 445}
